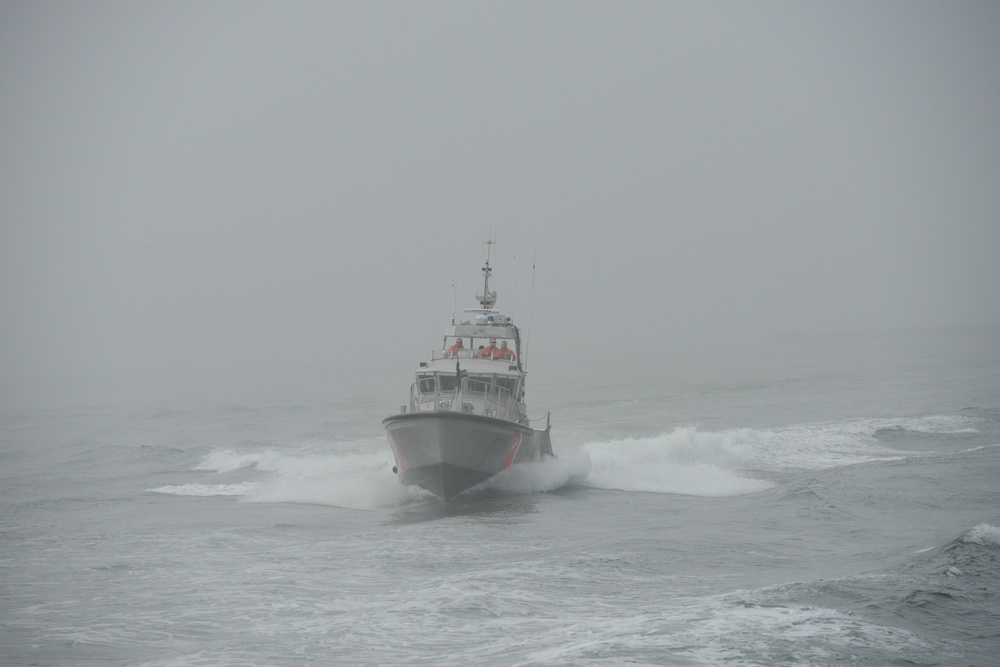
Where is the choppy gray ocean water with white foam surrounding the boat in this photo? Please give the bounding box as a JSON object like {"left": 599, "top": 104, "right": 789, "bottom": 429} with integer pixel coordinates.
{"left": 0, "top": 337, "right": 1000, "bottom": 666}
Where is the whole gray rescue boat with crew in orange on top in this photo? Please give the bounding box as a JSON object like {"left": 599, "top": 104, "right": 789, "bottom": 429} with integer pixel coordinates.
{"left": 382, "top": 241, "right": 552, "bottom": 502}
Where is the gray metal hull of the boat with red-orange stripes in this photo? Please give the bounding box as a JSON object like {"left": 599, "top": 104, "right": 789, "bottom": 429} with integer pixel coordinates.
{"left": 382, "top": 411, "right": 552, "bottom": 502}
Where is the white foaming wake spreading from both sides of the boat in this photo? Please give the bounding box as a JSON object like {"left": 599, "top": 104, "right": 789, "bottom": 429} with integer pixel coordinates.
{"left": 148, "top": 416, "right": 979, "bottom": 510}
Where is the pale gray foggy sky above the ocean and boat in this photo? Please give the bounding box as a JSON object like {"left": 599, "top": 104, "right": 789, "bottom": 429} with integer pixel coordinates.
{"left": 0, "top": 0, "right": 1000, "bottom": 385}
